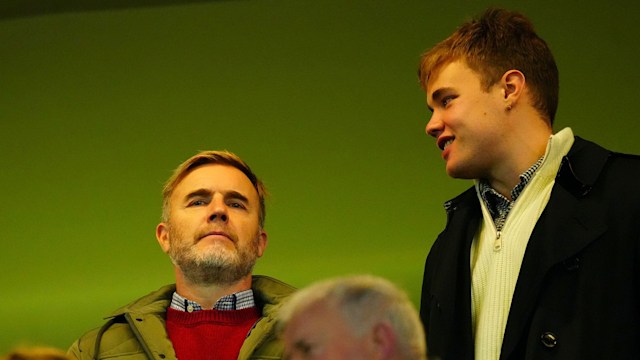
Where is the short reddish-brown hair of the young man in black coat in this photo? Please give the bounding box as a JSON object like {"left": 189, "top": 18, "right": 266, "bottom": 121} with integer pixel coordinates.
{"left": 418, "top": 8, "right": 559, "bottom": 124}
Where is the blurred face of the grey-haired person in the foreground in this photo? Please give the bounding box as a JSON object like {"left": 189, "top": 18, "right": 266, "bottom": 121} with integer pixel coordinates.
{"left": 283, "top": 303, "right": 377, "bottom": 360}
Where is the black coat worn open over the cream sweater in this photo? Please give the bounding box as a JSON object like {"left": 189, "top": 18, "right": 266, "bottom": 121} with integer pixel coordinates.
{"left": 420, "top": 137, "right": 640, "bottom": 360}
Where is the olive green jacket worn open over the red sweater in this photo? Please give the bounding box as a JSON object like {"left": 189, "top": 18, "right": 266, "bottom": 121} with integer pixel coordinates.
{"left": 69, "top": 276, "right": 295, "bottom": 360}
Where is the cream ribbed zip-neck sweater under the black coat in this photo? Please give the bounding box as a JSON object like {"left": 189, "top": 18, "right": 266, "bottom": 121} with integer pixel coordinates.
{"left": 471, "top": 128, "right": 573, "bottom": 360}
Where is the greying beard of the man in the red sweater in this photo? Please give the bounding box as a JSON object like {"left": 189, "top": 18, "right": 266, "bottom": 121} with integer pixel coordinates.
{"left": 168, "top": 226, "right": 260, "bottom": 286}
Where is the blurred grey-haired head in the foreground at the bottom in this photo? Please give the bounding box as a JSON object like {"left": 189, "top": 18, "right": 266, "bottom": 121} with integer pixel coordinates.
{"left": 279, "top": 275, "right": 426, "bottom": 360}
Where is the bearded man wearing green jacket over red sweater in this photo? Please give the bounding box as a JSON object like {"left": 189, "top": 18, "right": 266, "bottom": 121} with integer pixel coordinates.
{"left": 69, "top": 151, "right": 294, "bottom": 360}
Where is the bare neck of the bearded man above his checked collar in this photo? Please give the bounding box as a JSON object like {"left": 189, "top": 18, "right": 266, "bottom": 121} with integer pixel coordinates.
{"left": 175, "top": 268, "right": 251, "bottom": 309}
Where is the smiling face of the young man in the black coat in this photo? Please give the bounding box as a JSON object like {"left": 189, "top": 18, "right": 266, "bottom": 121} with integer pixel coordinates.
{"left": 426, "top": 61, "right": 509, "bottom": 179}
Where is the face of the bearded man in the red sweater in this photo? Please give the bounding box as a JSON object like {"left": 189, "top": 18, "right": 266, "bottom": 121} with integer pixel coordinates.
{"left": 156, "top": 164, "right": 267, "bottom": 285}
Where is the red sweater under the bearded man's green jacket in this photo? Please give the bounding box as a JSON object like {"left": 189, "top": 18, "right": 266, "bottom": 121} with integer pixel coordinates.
{"left": 167, "top": 307, "right": 260, "bottom": 360}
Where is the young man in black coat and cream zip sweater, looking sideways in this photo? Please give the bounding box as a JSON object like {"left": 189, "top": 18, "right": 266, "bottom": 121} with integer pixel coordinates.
{"left": 419, "top": 9, "right": 640, "bottom": 359}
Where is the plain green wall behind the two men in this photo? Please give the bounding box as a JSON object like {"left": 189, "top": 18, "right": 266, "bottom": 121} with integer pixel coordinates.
{"left": 0, "top": 0, "right": 640, "bottom": 353}
